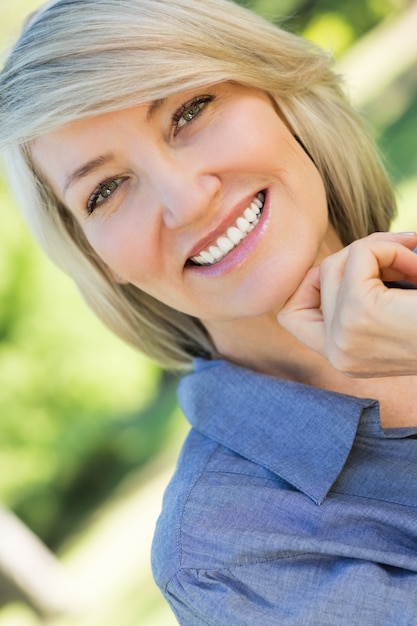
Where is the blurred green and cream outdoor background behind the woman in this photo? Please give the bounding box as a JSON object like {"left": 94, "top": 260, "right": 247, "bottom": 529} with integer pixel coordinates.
{"left": 0, "top": 0, "right": 417, "bottom": 626}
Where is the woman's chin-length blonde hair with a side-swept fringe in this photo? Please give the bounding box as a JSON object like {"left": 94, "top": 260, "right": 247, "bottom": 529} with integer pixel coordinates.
{"left": 0, "top": 0, "right": 395, "bottom": 368}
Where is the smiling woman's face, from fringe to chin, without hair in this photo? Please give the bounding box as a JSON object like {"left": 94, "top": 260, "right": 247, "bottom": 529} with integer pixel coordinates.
{"left": 33, "top": 83, "right": 338, "bottom": 332}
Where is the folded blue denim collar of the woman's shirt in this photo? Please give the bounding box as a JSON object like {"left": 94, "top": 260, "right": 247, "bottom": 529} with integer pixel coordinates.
{"left": 178, "top": 359, "right": 378, "bottom": 504}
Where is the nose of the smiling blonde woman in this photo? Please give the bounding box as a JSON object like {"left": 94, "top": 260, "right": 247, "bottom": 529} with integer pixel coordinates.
{"left": 150, "top": 154, "right": 221, "bottom": 230}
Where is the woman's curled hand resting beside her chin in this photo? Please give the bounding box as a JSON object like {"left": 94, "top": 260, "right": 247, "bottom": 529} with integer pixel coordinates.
{"left": 278, "top": 233, "right": 417, "bottom": 378}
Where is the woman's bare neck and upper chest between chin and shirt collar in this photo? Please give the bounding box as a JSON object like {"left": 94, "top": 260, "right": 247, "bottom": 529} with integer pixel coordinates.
{"left": 208, "top": 313, "right": 417, "bottom": 428}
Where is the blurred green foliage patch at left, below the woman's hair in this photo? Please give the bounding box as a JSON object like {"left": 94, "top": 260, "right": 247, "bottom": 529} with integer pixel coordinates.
{"left": 0, "top": 172, "right": 180, "bottom": 545}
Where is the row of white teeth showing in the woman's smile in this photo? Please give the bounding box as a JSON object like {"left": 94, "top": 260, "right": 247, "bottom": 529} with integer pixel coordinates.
{"left": 187, "top": 191, "right": 265, "bottom": 266}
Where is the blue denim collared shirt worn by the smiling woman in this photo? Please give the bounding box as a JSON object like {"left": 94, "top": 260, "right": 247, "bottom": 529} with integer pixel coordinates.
{"left": 152, "top": 361, "right": 417, "bottom": 626}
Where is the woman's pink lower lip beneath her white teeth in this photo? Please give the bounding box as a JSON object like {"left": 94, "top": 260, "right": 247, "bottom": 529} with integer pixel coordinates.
{"left": 186, "top": 189, "right": 270, "bottom": 277}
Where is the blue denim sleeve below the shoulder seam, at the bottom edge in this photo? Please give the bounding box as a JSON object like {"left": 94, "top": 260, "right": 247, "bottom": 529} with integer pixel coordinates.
{"left": 161, "top": 554, "right": 417, "bottom": 626}
